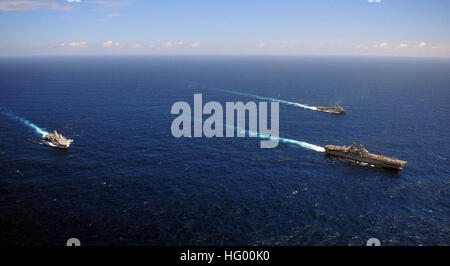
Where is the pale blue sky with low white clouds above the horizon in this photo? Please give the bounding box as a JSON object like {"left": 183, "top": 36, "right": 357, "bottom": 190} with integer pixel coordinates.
{"left": 0, "top": 0, "right": 450, "bottom": 57}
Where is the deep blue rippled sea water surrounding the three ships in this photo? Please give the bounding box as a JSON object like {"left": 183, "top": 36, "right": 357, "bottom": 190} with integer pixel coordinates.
{"left": 0, "top": 56, "right": 450, "bottom": 245}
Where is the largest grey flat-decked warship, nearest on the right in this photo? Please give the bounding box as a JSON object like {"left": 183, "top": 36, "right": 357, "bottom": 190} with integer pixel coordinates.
{"left": 325, "top": 143, "right": 407, "bottom": 170}
